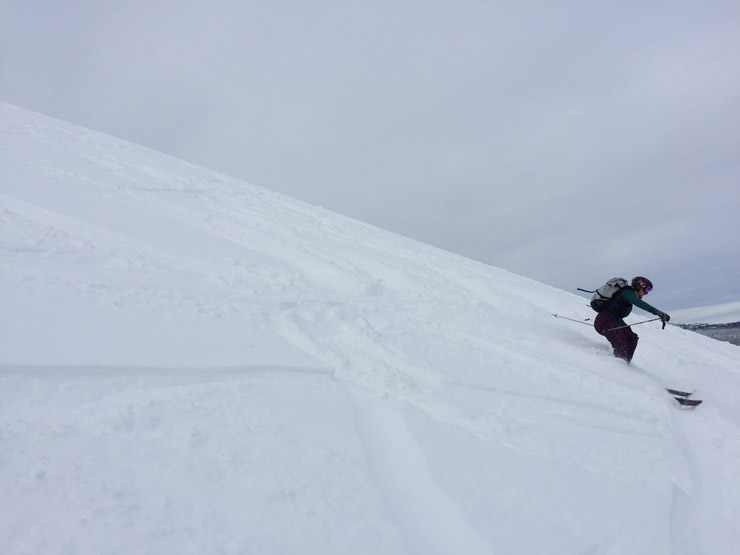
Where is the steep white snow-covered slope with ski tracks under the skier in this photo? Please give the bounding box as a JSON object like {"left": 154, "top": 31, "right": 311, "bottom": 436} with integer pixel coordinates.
{"left": 0, "top": 104, "right": 740, "bottom": 555}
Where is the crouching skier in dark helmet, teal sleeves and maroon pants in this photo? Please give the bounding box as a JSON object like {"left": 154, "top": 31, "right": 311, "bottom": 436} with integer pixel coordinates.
{"left": 594, "top": 276, "right": 671, "bottom": 364}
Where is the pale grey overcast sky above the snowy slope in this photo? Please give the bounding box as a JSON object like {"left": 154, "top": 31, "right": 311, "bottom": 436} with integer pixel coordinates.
{"left": 0, "top": 0, "right": 740, "bottom": 310}
